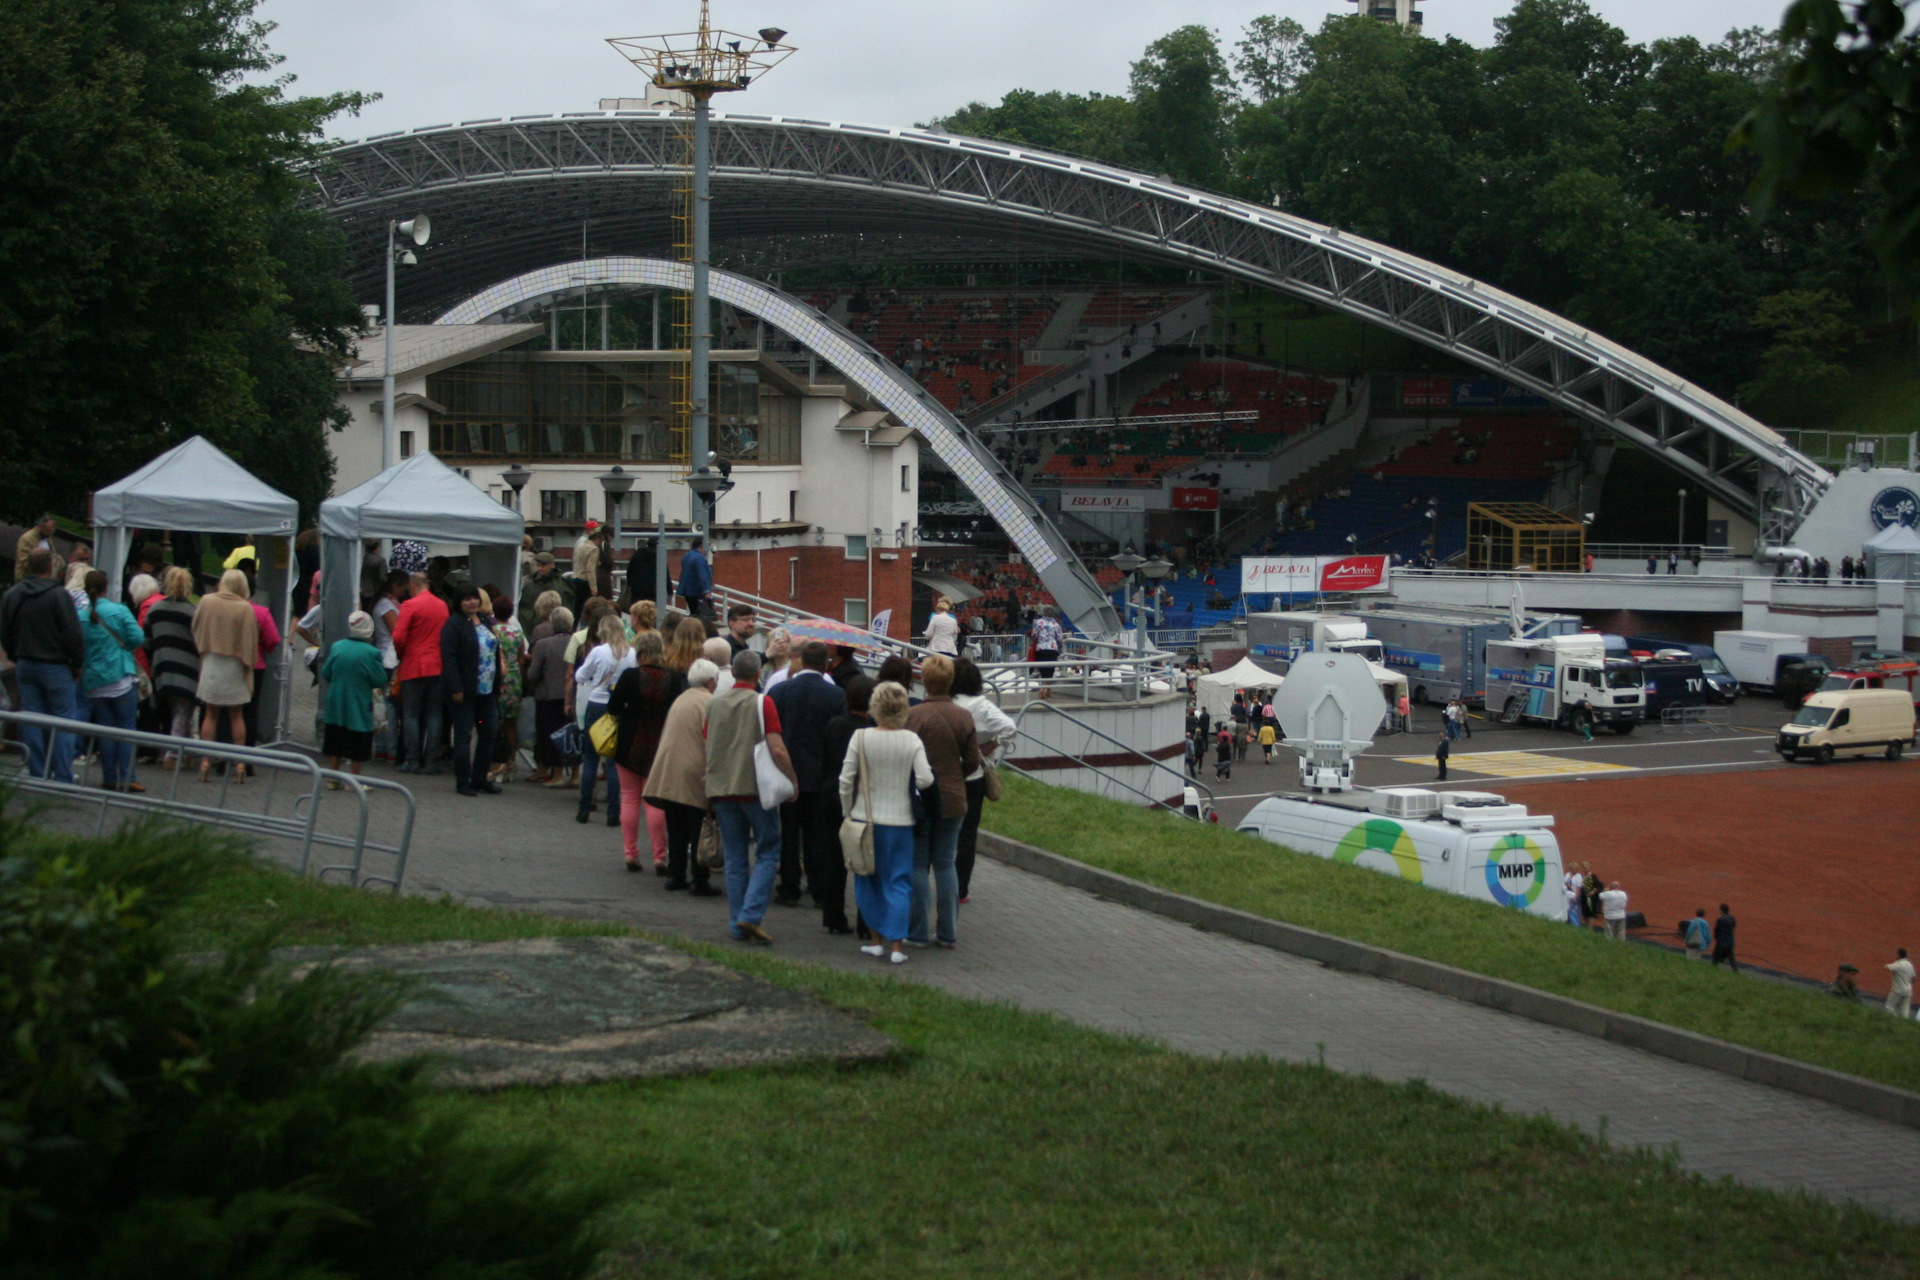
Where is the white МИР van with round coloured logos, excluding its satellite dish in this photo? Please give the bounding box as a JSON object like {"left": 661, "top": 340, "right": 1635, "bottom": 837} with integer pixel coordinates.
{"left": 1238, "top": 787, "right": 1567, "bottom": 919}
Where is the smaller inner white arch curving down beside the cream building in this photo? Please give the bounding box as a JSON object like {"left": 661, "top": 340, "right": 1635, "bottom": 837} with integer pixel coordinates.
{"left": 436, "top": 255, "right": 1119, "bottom": 637}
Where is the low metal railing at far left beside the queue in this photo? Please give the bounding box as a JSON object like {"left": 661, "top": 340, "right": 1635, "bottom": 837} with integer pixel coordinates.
{"left": 0, "top": 710, "right": 415, "bottom": 892}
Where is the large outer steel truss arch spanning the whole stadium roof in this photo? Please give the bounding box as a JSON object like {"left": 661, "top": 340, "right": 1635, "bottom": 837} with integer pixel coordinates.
{"left": 313, "top": 111, "right": 1832, "bottom": 543}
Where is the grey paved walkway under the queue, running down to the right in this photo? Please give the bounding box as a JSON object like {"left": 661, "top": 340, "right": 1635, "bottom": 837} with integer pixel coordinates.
{"left": 326, "top": 759, "right": 1920, "bottom": 1219}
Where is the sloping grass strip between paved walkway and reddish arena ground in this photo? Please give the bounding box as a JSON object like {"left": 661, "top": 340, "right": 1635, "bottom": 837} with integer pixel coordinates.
{"left": 985, "top": 777, "right": 1920, "bottom": 1090}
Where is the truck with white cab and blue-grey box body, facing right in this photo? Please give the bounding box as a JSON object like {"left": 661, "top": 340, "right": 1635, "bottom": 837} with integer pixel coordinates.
{"left": 1486, "top": 631, "right": 1647, "bottom": 735}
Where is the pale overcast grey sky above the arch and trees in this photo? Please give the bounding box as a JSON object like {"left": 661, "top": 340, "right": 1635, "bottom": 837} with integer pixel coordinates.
{"left": 259, "top": 0, "right": 1786, "bottom": 138}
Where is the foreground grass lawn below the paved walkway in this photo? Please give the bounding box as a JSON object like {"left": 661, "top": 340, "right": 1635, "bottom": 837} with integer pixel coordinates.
{"left": 161, "top": 844, "right": 1920, "bottom": 1280}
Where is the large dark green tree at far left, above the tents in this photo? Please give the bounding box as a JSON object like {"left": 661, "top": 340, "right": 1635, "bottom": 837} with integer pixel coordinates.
{"left": 0, "top": 0, "right": 363, "bottom": 512}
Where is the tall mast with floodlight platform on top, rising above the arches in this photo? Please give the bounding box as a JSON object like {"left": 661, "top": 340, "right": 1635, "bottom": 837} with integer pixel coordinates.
{"left": 607, "top": 11, "right": 793, "bottom": 498}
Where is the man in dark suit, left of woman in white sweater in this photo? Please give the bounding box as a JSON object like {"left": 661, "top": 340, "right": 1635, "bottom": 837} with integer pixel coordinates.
{"left": 766, "top": 641, "right": 852, "bottom": 933}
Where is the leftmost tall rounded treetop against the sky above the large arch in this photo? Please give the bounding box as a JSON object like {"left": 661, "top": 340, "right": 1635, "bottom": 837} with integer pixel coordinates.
{"left": 1131, "top": 25, "right": 1238, "bottom": 190}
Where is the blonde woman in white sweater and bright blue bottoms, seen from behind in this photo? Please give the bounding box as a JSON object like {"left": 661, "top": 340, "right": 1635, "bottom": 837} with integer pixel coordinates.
{"left": 841, "top": 679, "right": 933, "bottom": 965}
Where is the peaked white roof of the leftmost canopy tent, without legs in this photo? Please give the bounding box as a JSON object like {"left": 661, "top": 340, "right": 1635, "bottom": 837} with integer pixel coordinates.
{"left": 94, "top": 436, "right": 300, "bottom": 533}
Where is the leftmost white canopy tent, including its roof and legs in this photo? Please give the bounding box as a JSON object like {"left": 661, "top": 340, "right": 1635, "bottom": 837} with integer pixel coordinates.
{"left": 94, "top": 436, "right": 300, "bottom": 743}
